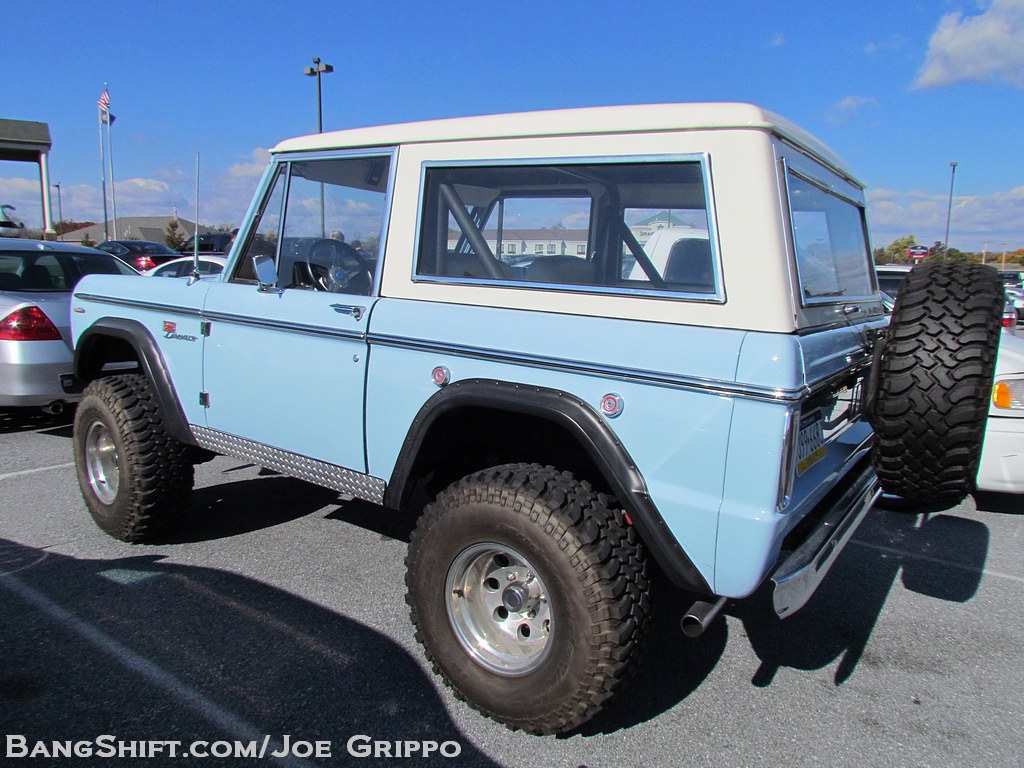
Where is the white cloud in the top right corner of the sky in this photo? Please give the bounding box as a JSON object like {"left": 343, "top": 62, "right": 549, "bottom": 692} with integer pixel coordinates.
{"left": 911, "top": 0, "right": 1024, "bottom": 88}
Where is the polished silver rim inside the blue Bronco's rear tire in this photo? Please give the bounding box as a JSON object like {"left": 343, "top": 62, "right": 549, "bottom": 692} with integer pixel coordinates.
{"left": 445, "top": 543, "right": 554, "bottom": 677}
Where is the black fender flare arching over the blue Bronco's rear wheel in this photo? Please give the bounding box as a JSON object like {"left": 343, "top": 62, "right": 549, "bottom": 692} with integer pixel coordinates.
{"left": 384, "top": 379, "right": 713, "bottom": 595}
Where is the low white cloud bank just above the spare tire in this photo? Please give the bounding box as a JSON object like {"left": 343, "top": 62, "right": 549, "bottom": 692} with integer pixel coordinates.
{"left": 867, "top": 185, "right": 1024, "bottom": 251}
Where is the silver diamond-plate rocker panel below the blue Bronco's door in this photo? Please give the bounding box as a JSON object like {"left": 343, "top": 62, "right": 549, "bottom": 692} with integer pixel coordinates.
{"left": 190, "top": 424, "right": 387, "bottom": 504}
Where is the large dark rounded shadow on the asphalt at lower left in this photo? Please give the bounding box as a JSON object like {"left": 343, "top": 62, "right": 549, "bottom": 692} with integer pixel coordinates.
{"left": 0, "top": 540, "right": 497, "bottom": 766}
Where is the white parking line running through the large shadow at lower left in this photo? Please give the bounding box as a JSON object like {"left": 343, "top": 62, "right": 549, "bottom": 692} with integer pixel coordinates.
{"left": 0, "top": 573, "right": 312, "bottom": 768}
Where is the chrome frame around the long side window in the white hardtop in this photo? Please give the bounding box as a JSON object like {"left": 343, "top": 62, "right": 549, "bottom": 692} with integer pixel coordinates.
{"left": 411, "top": 153, "right": 726, "bottom": 304}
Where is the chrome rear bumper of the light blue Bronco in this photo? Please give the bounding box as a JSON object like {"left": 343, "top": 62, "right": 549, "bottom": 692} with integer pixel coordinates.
{"left": 771, "top": 459, "right": 882, "bottom": 617}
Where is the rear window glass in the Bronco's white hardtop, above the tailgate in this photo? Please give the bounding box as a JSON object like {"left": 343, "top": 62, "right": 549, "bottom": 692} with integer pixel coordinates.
{"left": 787, "top": 170, "right": 874, "bottom": 305}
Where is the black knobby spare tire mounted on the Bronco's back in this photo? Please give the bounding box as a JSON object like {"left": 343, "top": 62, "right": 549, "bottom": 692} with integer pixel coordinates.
{"left": 870, "top": 262, "right": 1006, "bottom": 503}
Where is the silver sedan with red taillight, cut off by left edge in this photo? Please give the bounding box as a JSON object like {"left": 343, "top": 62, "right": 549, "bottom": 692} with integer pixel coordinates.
{"left": 0, "top": 240, "right": 136, "bottom": 414}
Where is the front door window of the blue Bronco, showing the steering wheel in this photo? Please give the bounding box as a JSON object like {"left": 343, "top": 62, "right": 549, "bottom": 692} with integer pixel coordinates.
{"left": 234, "top": 156, "right": 390, "bottom": 296}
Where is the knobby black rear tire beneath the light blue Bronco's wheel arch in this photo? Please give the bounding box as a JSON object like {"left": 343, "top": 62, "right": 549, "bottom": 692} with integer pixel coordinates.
{"left": 406, "top": 464, "right": 650, "bottom": 734}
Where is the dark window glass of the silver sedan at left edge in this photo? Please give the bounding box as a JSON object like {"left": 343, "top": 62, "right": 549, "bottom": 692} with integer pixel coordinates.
{"left": 0, "top": 251, "right": 137, "bottom": 292}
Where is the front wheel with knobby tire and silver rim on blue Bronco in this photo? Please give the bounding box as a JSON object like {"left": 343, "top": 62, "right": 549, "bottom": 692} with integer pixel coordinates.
{"left": 74, "top": 374, "right": 195, "bottom": 542}
